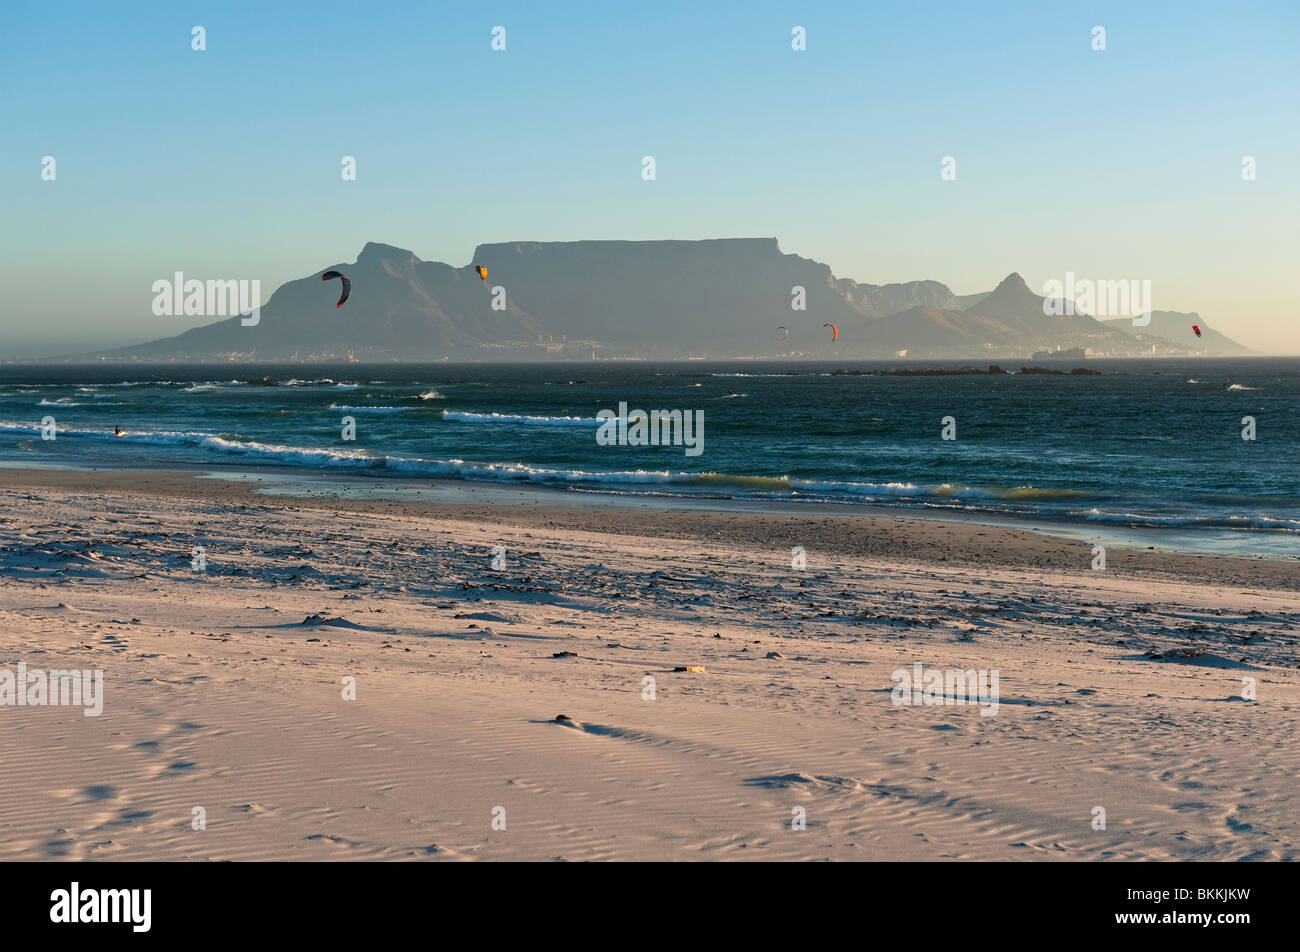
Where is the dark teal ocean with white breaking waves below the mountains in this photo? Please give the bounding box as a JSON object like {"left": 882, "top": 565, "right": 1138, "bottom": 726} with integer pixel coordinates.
{"left": 0, "top": 358, "right": 1300, "bottom": 558}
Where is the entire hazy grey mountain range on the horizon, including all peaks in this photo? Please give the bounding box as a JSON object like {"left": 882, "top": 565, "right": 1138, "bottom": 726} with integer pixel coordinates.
{"left": 103, "top": 238, "right": 1236, "bottom": 360}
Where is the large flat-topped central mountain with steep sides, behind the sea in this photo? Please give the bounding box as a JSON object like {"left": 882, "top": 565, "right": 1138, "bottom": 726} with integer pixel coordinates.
{"left": 475, "top": 238, "right": 956, "bottom": 356}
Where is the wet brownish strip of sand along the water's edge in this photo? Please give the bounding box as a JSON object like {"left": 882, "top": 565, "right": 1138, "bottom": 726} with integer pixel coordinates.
{"left": 0, "top": 467, "right": 1300, "bottom": 590}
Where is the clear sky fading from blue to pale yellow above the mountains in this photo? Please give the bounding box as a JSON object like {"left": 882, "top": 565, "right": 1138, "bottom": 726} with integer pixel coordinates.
{"left": 0, "top": 0, "right": 1300, "bottom": 359}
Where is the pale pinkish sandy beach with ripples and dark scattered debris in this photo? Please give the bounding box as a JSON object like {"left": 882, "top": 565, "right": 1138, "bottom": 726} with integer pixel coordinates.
{"left": 0, "top": 468, "right": 1300, "bottom": 861}
